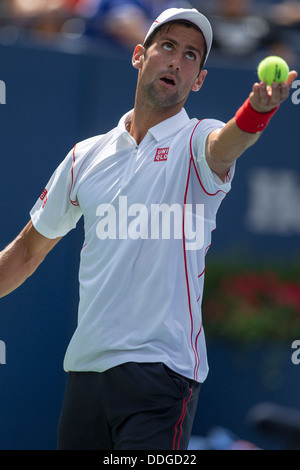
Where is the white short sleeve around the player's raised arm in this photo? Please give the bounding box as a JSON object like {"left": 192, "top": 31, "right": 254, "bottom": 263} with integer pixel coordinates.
{"left": 192, "top": 119, "right": 235, "bottom": 193}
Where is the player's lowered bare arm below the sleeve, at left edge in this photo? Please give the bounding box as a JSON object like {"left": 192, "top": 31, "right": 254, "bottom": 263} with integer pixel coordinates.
{"left": 0, "top": 221, "right": 62, "bottom": 297}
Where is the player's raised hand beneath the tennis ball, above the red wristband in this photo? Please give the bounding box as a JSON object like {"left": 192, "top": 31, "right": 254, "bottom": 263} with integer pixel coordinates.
{"left": 250, "top": 70, "right": 298, "bottom": 113}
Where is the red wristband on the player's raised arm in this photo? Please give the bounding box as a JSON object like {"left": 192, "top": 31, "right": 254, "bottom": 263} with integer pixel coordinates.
{"left": 235, "top": 98, "right": 279, "bottom": 134}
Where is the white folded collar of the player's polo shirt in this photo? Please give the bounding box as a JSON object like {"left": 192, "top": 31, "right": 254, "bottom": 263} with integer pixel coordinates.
{"left": 111, "top": 108, "right": 190, "bottom": 143}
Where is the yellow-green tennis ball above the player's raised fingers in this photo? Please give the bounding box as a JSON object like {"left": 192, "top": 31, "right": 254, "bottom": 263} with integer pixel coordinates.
{"left": 257, "top": 56, "right": 290, "bottom": 85}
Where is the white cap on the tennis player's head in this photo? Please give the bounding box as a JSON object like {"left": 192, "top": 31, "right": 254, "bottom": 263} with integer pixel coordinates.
{"left": 144, "top": 8, "right": 213, "bottom": 62}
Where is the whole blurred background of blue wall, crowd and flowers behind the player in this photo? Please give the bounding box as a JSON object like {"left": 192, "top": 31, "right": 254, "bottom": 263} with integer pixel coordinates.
{"left": 0, "top": 0, "right": 300, "bottom": 450}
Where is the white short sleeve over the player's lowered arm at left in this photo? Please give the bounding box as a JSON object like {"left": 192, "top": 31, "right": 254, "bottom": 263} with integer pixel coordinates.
{"left": 30, "top": 150, "right": 82, "bottom": 239}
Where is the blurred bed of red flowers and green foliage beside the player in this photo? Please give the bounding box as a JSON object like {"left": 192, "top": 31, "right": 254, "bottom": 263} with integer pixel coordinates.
{"left": 203, "top": 269, "right": 300, "bottom": 342}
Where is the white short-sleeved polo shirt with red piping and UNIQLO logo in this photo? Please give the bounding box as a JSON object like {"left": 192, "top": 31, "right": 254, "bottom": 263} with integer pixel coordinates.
{"left": 30, "top": 109, "right": 234, "bottom": 382}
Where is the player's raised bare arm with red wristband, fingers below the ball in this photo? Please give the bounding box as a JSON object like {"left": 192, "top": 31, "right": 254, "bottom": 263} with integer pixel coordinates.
{"left": 206, "top": 71, "right": 298, "bottom": 181}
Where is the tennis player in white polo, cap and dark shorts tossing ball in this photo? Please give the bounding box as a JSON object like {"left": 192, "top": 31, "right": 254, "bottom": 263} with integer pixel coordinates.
{"left": 0, "top": 8, "right": 297, "bottom": 450}
